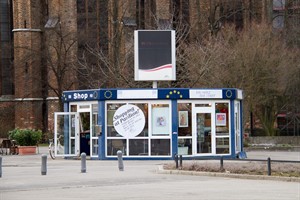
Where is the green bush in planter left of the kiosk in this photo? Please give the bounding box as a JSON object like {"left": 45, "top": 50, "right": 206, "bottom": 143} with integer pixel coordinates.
{"left": 8, "top": 128, "right": 42, "bottom": 146}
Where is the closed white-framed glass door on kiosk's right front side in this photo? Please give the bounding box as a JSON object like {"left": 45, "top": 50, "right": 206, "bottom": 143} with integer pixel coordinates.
{"left": 192, "top": 107, "right": 215, "bottom": 154}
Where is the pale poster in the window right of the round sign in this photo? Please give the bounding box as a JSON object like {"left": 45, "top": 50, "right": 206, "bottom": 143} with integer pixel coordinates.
{"left": 152, "top": 107, "right": 170, "bottom": 135}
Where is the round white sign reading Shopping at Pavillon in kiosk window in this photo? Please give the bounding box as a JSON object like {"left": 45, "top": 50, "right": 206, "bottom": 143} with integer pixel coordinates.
{"left": 113, "top": 104, "right": 145, "bottom": 138}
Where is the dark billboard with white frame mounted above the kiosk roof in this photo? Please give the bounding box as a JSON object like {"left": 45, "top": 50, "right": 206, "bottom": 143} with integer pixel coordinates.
{"left": 134, "top": 30, "right": 176, "bottom": 81}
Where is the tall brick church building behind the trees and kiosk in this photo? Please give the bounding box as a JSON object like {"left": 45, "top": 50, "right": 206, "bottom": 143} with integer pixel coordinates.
{"left": 0, "top": 0, "right": 299, "bottom": 136}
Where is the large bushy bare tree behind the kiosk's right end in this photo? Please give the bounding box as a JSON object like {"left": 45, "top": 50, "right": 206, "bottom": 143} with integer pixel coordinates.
{"left": 189, "top": 24, "right": 298, "bottom": 135}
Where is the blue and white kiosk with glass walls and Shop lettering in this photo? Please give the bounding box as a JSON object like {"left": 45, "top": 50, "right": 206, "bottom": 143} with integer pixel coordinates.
{"left": 55, "top": 88, "right": 243, "bottom": 160}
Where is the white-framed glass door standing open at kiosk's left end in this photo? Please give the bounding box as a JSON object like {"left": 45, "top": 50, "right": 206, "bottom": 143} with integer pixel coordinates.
{"left": 54, "top": 112, "right": 79, "bottom": 157}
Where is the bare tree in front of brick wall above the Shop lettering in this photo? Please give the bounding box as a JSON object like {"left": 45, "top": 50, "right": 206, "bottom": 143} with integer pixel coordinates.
{"left": 41, "top": 23, "right": 77, "bottom": 111}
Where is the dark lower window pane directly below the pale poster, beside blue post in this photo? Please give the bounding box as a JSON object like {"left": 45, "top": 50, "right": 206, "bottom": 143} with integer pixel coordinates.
{"left": 151, "top": 139, "right": 170, "bottom": 156}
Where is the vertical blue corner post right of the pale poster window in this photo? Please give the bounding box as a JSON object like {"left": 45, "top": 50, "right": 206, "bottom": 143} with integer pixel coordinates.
{"left": 171, "top": 100, "right": 178, "bottom": 157}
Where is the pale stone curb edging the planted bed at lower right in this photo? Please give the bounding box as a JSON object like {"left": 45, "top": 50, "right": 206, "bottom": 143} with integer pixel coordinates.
{"left": 156, "top": 165, "right": 300, "bottom": 183}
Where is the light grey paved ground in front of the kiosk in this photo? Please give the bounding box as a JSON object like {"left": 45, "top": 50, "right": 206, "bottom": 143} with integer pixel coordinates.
{"left": 0, "top": 149, "right": 300, "bottom": 200}
